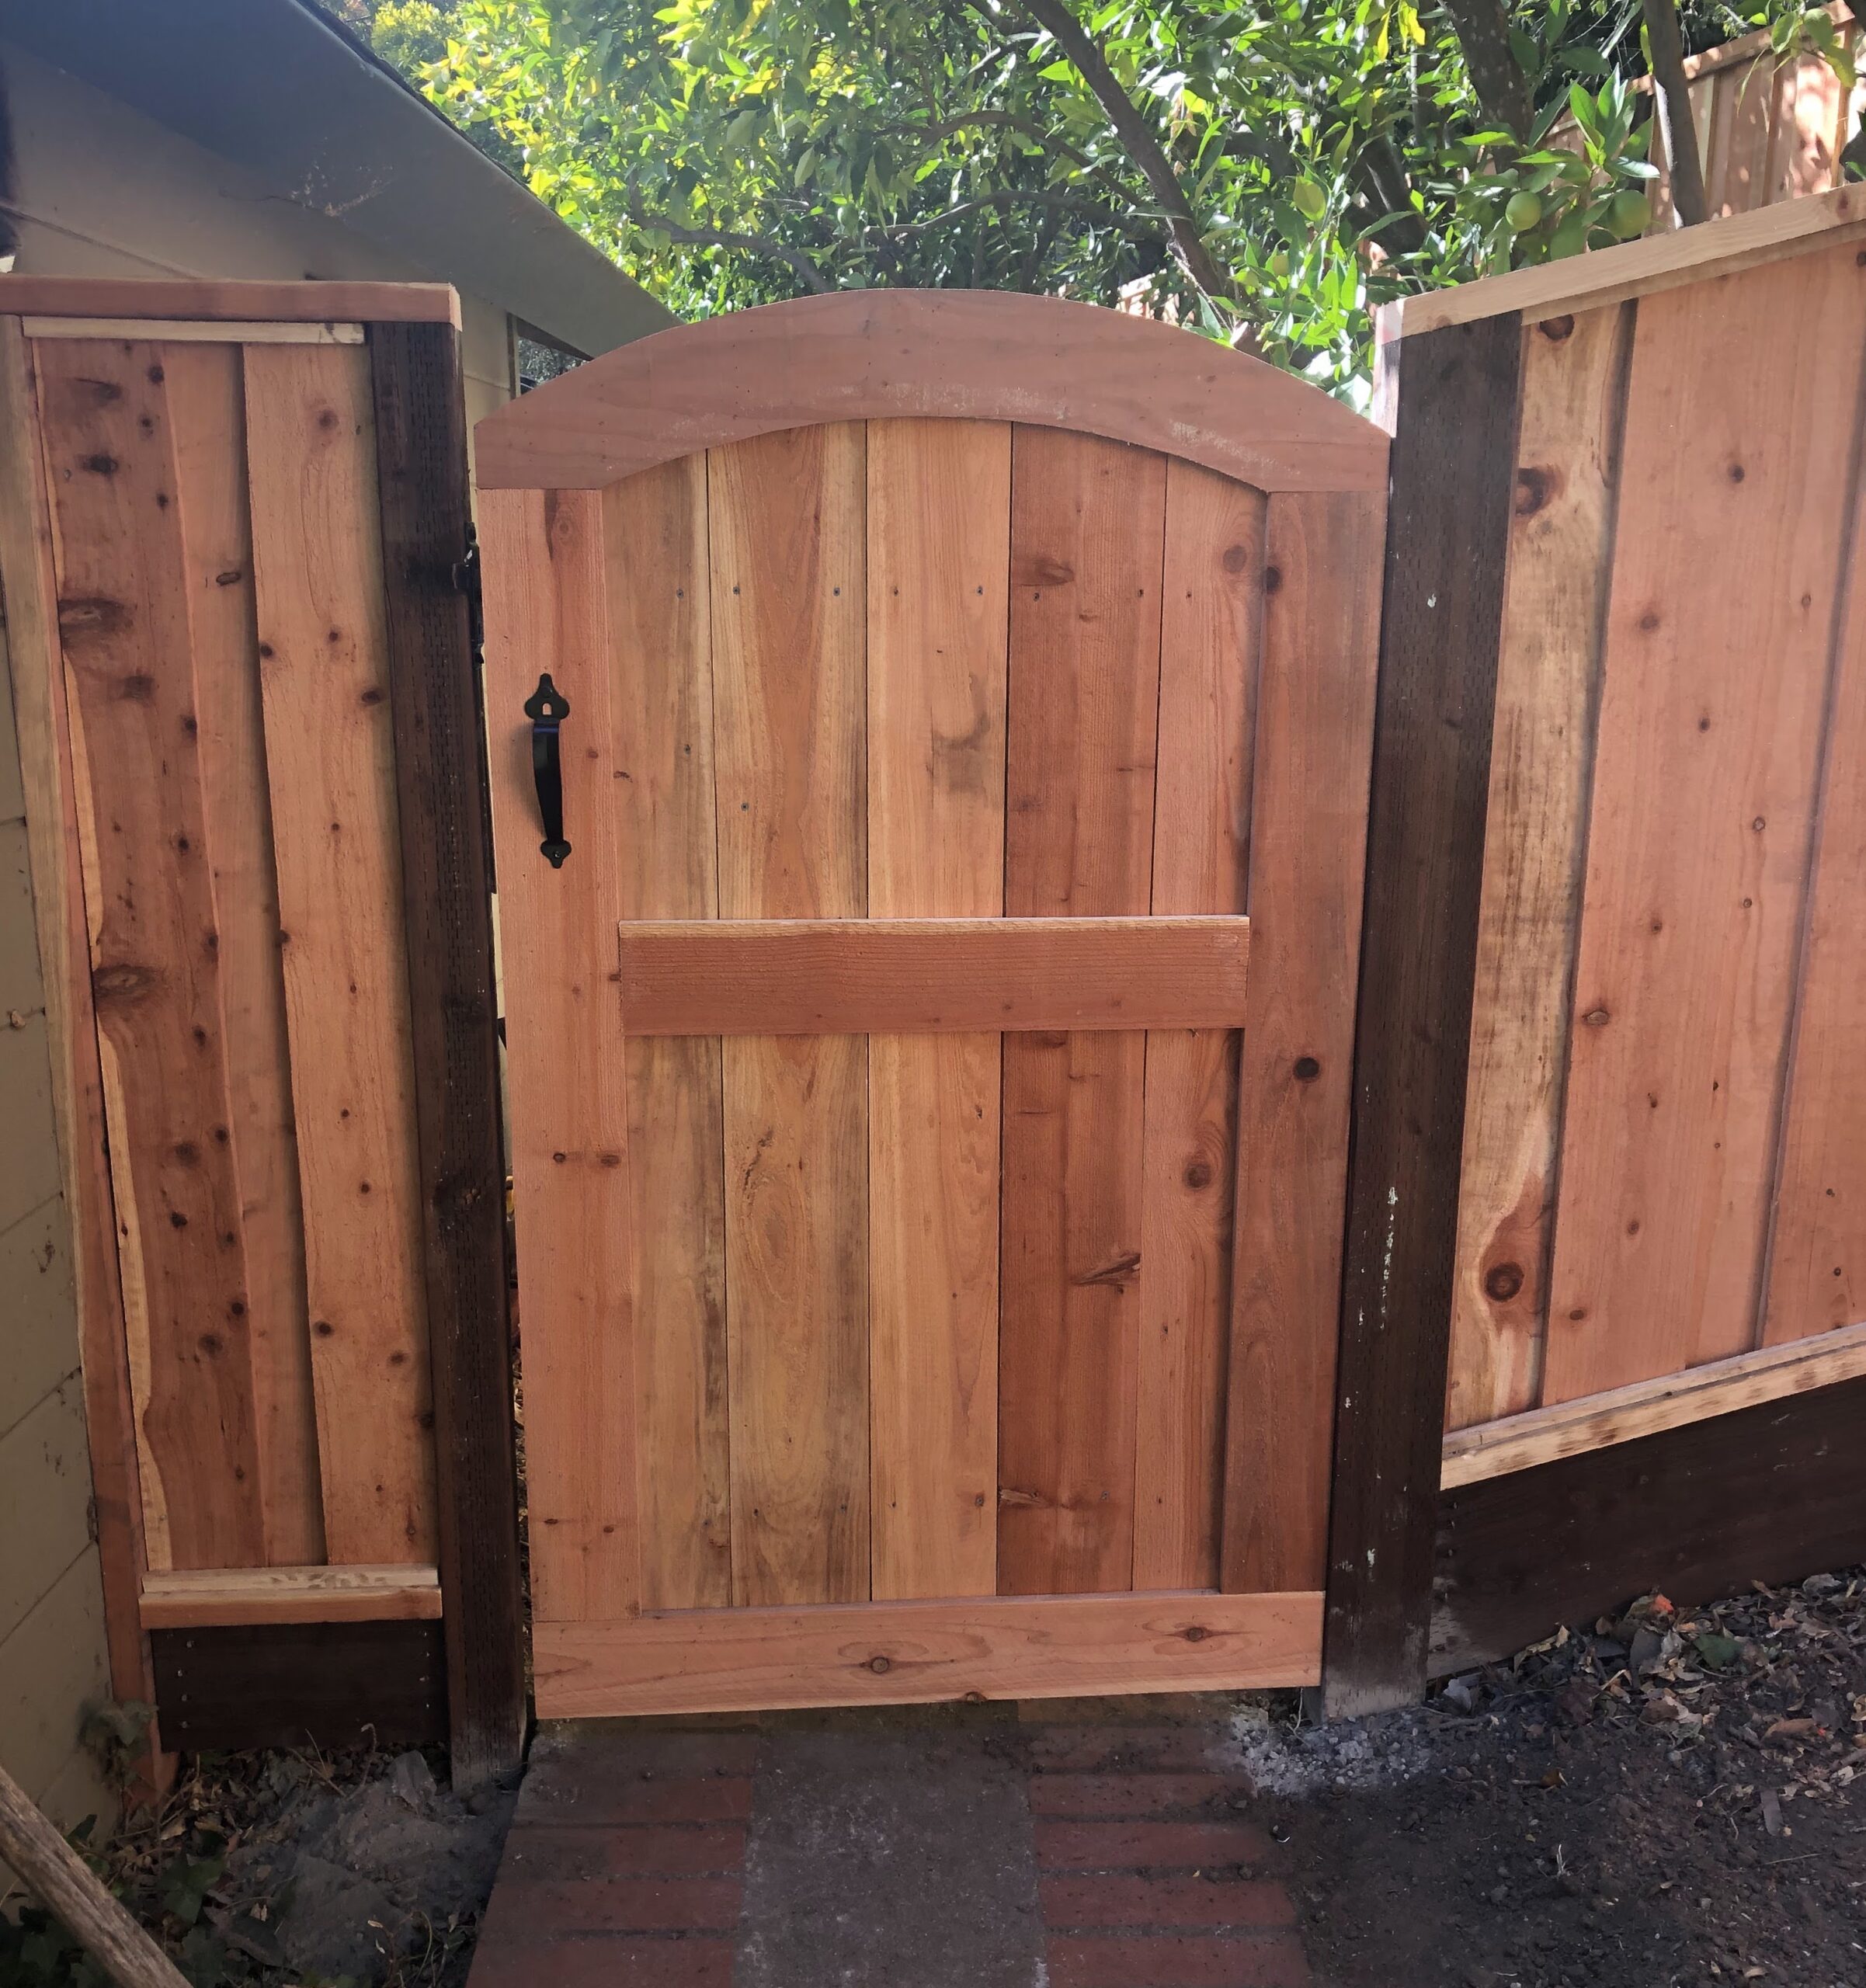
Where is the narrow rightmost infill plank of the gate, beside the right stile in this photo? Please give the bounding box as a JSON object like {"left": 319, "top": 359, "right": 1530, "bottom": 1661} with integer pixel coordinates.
{"left": 1135, "top": 461, "right": 1264, "bottom": 1588}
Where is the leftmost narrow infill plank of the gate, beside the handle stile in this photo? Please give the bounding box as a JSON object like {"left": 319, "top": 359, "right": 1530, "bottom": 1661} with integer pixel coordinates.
{"left": 608, "top": 455, "right": 731, "bottom": 1608}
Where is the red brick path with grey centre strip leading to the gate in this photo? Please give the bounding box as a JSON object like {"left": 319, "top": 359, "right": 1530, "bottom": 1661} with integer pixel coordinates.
{"left": 471, "top": 1715, "right": 1312, "bottom": 1988}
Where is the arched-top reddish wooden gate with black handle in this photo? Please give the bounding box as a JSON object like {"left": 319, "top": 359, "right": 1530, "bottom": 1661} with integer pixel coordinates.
{"left": 477, "top": 292, "right": 1387, "bottom": 1715}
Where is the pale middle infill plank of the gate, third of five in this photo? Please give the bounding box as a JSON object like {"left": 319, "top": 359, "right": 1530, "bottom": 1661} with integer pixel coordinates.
{"left": 868, "top": 422, "right": 1012, "bottom": 1600}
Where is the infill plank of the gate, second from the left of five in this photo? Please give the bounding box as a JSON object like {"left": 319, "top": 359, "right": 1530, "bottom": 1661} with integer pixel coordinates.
{"left": 707, "top": 423, "right": 870, "bottom": 1604}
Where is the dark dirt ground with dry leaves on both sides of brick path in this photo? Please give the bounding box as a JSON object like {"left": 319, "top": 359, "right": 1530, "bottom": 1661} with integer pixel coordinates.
{"left": 0, "top": 1570, "right": 1866, "bottom": 1988}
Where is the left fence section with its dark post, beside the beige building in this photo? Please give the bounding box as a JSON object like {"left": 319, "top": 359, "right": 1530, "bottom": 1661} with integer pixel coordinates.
{"left": 0, "top": 276, "right": 519, "bottom": 1778}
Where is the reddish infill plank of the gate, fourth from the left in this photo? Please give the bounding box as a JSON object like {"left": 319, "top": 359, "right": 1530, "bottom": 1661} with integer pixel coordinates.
{"left": 998, "top": 427, "right": 1166, "bottom": 1594}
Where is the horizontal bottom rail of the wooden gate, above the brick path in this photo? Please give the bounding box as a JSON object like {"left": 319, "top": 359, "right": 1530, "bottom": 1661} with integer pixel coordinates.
{"left": 537, "top": 1593, "right": 1322, "bottom": 1719}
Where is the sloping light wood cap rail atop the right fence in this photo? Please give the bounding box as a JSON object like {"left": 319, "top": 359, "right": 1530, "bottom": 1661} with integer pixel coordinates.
{"left": 1377, "top": 187, "right": 1866, "bottom": 344}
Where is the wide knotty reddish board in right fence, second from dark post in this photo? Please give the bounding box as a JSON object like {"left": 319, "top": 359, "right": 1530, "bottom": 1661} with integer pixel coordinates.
{"left": 1542, "top": 248, "right": 1866, "bottom": 1406}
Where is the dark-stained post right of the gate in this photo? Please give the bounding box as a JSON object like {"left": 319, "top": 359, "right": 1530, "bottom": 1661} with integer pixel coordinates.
{"left": 1323, "top": 314, "right": 1522, "bottom": 1718}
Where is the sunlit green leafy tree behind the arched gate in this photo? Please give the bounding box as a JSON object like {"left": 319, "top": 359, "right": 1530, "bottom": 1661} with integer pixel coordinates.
{"left": 389, "top": 0, "right": 1846, "bottom": 394}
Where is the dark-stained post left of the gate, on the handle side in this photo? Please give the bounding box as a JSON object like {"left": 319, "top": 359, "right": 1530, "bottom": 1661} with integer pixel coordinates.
{"left": 370, "top": 324, "right": 525, "bottom": 1789}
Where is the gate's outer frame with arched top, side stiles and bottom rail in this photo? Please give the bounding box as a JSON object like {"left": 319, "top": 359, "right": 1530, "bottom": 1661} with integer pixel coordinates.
{"left": 475, "top": 290, "right": 1391, "bottom": 1718}
